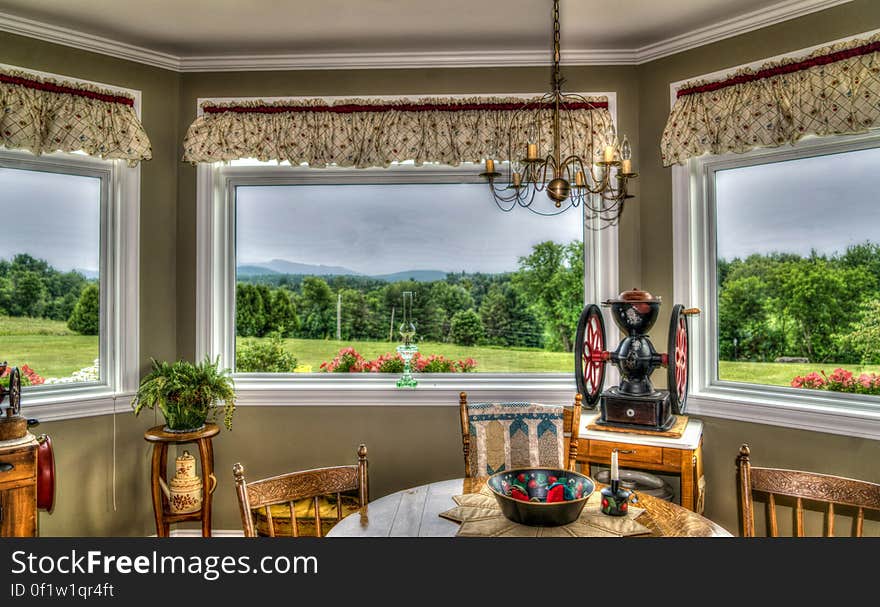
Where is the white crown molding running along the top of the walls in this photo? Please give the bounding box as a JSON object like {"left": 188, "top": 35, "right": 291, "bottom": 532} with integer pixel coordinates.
{"left": 0, "top": 0, "right": 852, "bottom": 72}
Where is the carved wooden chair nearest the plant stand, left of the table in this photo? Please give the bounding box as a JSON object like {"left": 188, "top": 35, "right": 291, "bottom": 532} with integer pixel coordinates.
{"left": 232, "top": 445, "right": 369, "bottom": 537}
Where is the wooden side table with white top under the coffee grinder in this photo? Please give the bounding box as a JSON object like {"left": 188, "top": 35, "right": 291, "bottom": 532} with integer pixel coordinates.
{"left": 577, "top": 414, "right": 706, "bottom": 514}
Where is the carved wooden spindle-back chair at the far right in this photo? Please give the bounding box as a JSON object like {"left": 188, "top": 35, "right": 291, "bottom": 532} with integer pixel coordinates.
{"left": 736, "top": 444, "right": 880, "bottom": 537}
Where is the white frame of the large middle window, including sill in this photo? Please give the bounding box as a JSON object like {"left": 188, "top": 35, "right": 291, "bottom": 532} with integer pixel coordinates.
{"left": 196, "top": 93, "right": 618, "bottom": 406}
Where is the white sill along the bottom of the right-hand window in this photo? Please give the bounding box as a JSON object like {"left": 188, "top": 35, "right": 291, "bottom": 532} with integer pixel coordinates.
{"left": 688, "top": 386, "right": 880, "bottom": 440}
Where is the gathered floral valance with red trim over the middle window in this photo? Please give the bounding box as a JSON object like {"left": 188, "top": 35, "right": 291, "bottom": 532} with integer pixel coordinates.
{"left": 183, "top": 97, "right": 614, "bottom": 168}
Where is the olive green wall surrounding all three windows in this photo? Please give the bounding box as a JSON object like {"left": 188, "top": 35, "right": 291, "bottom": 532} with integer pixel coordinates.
{"left": 6, "top": 0, "right": 880, "bottom": 535}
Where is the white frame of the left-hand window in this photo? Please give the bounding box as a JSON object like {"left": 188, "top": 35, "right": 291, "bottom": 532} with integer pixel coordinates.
{"left": 0, "top": 65, "right": 141, "bottom": 422}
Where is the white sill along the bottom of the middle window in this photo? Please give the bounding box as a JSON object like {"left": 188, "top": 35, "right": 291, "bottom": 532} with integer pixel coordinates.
{"left": 235, "top": 373, "right": 577, "bottom": 407}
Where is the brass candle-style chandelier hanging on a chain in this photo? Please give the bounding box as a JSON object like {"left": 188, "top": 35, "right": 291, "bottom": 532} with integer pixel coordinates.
{"left": 481, "top": 0, "right": 638, "bottom": 229}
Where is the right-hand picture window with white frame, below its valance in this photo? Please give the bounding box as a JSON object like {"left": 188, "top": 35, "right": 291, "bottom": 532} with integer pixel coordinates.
{"left": 673, "top": 132, "right": 880, "bottom": 437}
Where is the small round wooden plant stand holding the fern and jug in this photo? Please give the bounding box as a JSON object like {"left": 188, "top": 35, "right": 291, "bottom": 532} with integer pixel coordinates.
{"left": 144, "top": 424, "right": 220, "bottom": 537}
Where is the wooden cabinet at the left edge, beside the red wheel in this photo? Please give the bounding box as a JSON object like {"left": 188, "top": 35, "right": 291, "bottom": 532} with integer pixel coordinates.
{"left": 0, "top": 440, "right": 37, "bottom": 537}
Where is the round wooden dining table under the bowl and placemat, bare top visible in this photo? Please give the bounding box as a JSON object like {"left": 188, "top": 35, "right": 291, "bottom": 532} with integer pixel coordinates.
{"left": 327, "top": 478, "right": 731, "bottom": 537}
